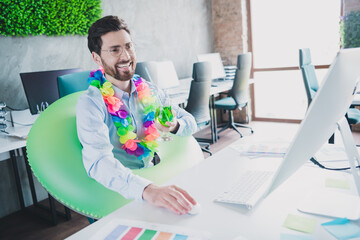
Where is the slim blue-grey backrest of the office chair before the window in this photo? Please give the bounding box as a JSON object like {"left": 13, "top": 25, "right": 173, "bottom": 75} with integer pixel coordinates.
{"left": 299, "top": 48, "right": 319, "bottom": 106}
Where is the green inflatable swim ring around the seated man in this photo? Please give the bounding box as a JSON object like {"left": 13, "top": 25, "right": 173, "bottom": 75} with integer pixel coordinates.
{"left": 26, "top": 92, "right": 204, "bottom": 219}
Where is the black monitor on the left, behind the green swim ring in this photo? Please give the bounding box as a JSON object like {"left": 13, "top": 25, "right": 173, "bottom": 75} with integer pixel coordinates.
{"left": 20, "top": 68, "right": 82, "bottom": 114}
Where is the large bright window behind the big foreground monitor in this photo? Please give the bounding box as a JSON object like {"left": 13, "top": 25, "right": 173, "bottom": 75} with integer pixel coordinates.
{"left": 250, "top": 0, "right": 341, "bottom": 120}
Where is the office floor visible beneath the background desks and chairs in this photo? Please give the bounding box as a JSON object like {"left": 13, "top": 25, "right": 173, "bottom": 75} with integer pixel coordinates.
{"left": 0, "top": 122, "right": 360, "bottom": 240}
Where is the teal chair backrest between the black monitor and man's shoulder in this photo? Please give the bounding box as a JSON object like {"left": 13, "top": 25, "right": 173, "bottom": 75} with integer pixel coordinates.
{"left": 57, "top": 71, "right": 90, "bottom": 98}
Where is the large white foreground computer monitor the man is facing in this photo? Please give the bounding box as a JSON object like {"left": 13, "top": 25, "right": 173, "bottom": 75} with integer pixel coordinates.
{"left": 268, "top": 48, "right": 360, "bottom": 219}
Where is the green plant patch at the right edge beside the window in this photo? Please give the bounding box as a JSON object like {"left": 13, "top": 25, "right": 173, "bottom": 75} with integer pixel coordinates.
{"left": 340, "top": 12, "right": 360, "bottom": 48}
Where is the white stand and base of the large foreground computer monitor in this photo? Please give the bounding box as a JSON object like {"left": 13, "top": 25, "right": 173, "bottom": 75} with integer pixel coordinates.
{"left": 298, "top": 117, "right": 360, "bottom": 220}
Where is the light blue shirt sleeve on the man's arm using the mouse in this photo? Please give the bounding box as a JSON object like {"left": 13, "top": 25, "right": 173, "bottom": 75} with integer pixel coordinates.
{"left": 76, "top": 90, "right": 151, "bottom": 200}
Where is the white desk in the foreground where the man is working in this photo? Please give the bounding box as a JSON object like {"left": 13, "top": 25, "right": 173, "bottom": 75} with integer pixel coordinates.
{"left": 68, "top": 137, "right": 360, "bottom": 240}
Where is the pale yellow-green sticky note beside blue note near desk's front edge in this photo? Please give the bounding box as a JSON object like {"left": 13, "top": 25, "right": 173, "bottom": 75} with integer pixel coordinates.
{"left": 283, "top": 214, "right": 316, "bottom": 233}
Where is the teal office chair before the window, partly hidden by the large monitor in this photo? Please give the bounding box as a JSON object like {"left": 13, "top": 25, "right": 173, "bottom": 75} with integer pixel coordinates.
{"left": 299, "top": 48, "right": 360, "bottom": 127}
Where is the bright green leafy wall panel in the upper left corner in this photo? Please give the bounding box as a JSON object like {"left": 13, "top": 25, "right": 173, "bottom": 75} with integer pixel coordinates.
{"left": 0, "top": 0, "right": 102, "bottom": 36}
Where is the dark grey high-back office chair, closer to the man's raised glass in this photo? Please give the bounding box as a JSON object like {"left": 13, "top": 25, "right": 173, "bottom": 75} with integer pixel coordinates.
{"left": 185, "top": 62, "right": 212, "bottom": 156}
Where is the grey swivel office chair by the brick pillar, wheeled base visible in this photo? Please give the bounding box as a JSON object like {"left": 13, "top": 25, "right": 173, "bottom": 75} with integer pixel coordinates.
{"left": 215, "top": 53, "right": 254, "bottom": 137}
